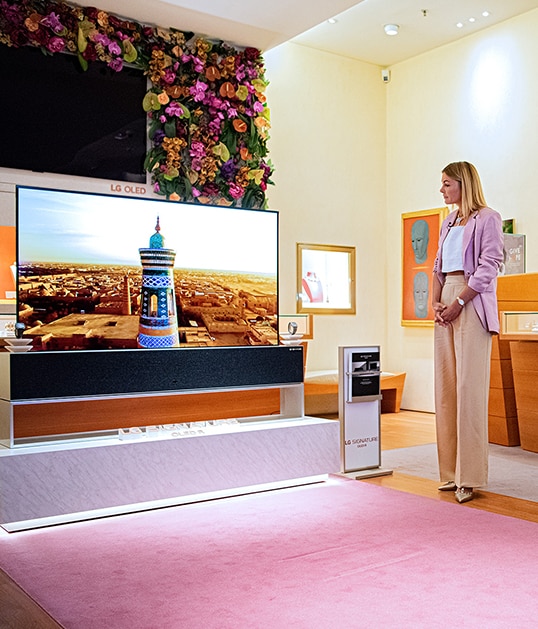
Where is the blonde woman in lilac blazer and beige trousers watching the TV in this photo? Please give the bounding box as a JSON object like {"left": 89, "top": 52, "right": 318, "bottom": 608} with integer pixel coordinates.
{"left": 432, "top": 162, "right": 503, "bottom": 502}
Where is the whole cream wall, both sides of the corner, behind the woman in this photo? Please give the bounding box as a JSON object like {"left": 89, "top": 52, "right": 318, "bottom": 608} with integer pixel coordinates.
{"left": 265, "top": 10, "right": 538, "bottom": 411}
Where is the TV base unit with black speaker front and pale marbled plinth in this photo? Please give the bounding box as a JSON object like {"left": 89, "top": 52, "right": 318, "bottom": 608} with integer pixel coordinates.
{"left": 0, "top": 346, "right": 340, "bottom": 532}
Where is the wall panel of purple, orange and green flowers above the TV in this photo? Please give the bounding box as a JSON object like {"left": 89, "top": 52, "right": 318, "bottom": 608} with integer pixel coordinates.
{"left": 0, "top": 0, "right": 272, "bottom": 208}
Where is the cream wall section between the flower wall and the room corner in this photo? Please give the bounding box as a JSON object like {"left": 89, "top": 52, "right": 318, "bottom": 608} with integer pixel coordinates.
{"left": 264, "top": 43, "right": 388, "bottom": 370}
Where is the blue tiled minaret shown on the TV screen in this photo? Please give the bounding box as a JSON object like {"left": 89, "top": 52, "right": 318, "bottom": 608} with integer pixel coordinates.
{"left": 138, "top": 217, "right": 179, "bottom": 349}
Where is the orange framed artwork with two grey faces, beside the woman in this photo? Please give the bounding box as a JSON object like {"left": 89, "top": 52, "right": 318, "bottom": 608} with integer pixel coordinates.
{"left": 402, "top": 207, "right": 448, "bottom": 326}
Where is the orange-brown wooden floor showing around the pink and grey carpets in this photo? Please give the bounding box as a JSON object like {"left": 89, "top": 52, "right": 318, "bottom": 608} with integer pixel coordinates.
{"left": 0, "top": 411, "right": 538, "bottom": 629}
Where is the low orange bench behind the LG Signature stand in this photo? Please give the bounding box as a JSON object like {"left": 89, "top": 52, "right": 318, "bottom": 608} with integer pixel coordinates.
{"left": 304, "top": 370, "right": 405, "bottom": 416}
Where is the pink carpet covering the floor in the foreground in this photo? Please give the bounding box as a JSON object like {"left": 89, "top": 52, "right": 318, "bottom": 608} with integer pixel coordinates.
{"left": 0, "top": 477, "right": 538, "bottom": 629}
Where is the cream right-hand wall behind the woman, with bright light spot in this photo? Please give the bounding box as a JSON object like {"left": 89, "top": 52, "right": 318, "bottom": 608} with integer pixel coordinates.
{"left": 384, "top": 10, "right": 538, "bottom": 411}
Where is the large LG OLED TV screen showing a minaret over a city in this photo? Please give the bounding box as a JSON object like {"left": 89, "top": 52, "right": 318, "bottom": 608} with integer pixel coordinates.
{"left": 17, "top": 186, "right": 278, "bottom": 351}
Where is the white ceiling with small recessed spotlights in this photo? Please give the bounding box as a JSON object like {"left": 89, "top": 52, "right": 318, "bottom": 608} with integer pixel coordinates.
{"left": 94, "top": 0, "right": 538, "bottom": 66}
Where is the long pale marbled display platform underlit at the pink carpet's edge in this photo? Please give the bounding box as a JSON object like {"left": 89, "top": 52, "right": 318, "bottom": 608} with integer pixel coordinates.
{"left": 0, "top": 417, "right": 340, "bottom": 532}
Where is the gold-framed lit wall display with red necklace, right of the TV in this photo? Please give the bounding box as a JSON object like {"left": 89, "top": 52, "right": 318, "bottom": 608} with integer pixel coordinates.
{"left": 297, "top": 243, "right": 355, "bottom": 314}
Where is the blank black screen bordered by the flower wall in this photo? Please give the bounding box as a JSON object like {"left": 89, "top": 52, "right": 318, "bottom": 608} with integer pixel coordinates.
{"left": 0, "top": 44, "right": 147, "bottom": 183}
